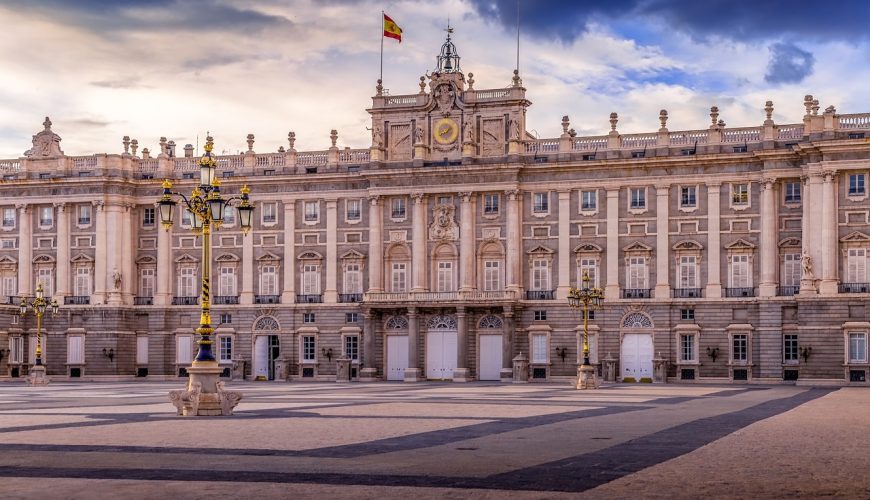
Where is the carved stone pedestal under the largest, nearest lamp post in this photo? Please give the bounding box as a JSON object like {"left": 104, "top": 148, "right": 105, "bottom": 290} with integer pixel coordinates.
{"left": 169, "top": 364, "right": 242, "bottom": 417}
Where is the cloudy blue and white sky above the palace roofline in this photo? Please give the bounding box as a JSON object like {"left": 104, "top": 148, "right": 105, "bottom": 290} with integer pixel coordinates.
{"left": 0, "top": 0, "right": 870, "bottom": 158}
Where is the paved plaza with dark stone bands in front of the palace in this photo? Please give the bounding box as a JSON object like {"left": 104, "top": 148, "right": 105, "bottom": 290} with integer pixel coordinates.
{"left": 0, "top": 381, "right": 870, "bottom": 498}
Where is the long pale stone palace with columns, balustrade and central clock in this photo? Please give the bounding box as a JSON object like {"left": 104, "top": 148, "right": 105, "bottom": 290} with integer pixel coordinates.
{"left": 0, "top": 37, "right": 870, "bottom": 384}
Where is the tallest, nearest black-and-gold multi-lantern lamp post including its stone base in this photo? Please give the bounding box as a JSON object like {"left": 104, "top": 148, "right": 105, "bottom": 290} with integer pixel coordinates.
{"left": 157, "top": 136, "right": 254, "bottom": 415}
